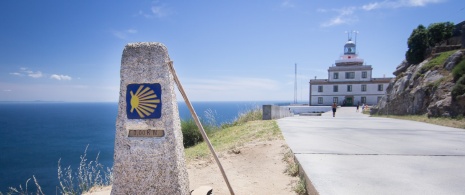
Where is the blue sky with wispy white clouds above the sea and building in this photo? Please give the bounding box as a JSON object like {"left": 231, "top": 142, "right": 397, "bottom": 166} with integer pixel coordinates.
{"left": 0, "top": 0, "right": 465, "bottom": 102}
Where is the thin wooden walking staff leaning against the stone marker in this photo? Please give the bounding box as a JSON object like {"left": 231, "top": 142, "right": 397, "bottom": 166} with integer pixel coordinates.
{"left": 168, "top": 61, "right": 234, "bottom": 195}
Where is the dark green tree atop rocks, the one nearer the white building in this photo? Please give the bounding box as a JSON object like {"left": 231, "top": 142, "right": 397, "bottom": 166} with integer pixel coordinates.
{"left": 405, "top": 24, "right": 428, "bottom": 64}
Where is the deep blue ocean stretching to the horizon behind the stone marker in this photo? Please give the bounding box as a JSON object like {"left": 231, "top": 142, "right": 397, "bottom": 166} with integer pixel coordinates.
{"left": 0, "top": 102, "right": 283, "bottom": 194}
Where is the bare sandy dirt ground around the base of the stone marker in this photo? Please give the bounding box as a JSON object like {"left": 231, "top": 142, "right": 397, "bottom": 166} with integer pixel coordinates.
{"left": 87, "top": 140, "right": 298, "bottom": 195}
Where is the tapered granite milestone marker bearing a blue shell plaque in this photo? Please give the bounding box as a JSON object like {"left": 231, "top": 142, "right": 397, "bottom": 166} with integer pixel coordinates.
{"left": 111, "top": 43, "right": 189, "bottom": 195}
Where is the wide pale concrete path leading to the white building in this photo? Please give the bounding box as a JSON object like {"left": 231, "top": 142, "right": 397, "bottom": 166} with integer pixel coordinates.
{"left": 278, "top": 107, "right": 465, "bottom": 195}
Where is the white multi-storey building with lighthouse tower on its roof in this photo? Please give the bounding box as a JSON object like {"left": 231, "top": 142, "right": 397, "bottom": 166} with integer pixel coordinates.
{"left": 309, "top": 38, "right": 392, "bottom": 106}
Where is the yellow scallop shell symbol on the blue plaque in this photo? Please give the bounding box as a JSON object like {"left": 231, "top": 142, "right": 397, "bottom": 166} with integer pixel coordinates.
{"left": 130, "top": 85, "right": 160, "bottom": 118}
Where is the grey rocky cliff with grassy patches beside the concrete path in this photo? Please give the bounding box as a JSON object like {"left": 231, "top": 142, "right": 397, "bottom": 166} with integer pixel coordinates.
{"left": 372, "top": 46, "right": 465, "bottom": 117}
